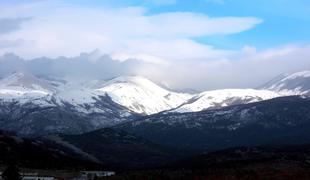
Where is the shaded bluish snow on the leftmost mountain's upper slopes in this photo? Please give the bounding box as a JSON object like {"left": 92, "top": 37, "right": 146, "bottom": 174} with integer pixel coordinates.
{"left": 0, "top": 72, "right": 110, "bottom": 113}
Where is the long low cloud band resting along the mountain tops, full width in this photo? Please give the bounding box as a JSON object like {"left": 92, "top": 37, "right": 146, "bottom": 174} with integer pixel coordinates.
{"left": 0, "top": 45, "right": 310, "bottom": 91}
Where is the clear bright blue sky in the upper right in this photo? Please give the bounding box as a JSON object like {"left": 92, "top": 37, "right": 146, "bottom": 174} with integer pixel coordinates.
{"left": 68, "top": 0, "right": 310, "bottom": 49}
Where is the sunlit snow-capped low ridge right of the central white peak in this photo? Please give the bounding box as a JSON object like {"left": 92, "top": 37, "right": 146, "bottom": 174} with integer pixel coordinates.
{"left": 170, "top": 89, "right": 280, "bottom": 113}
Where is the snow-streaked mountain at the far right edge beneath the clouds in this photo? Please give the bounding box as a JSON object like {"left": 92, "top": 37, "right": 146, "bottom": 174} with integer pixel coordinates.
{"left": 260, "top": 71, "right": 310, "bottom": 95}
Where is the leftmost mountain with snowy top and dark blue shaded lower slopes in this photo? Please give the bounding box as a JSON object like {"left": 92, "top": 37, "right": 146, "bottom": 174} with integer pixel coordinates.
{"left": 0, "top": 72, "right": 136, "bottom": 136}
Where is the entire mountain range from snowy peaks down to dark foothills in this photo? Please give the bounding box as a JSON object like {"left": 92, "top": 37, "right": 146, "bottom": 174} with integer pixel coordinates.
{"left": 0, "top": 68, "right": 310, "bottom": 169}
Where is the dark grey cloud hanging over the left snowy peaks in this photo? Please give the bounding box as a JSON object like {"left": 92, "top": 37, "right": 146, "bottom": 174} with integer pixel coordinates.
{"left": 0, "top": 53, "right": 151, "bottom": 79}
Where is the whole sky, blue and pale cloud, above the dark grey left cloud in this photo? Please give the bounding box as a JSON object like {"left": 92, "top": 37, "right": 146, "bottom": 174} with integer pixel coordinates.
{"left": 0, "top": 0, "right": 310, "bottom": 90}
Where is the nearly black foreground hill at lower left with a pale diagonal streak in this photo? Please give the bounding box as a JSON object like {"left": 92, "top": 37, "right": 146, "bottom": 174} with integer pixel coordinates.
{"left": 0, "top": 128, "right": 181, "bottom": 170}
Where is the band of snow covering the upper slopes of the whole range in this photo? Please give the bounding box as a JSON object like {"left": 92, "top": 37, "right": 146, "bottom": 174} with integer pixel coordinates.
{"left": 0, "top": 71, "right": 310, "bottom": 117}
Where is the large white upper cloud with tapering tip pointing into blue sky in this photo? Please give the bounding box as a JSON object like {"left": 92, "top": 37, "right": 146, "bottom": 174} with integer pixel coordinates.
{"left": 0, "top": 1, "right": 262, "bottom": 60}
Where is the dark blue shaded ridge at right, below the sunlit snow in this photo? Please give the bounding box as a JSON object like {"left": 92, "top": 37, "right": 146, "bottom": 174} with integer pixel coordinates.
{"left": 115, "top": 96, "right": 310, "bottom": 152}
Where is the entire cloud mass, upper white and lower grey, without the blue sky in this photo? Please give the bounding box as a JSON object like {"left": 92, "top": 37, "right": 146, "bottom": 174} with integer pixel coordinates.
{"left": 0, "top": 0, "right": 310, "bottom": 90}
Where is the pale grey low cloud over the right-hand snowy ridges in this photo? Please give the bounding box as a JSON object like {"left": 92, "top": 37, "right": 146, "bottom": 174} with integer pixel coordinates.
{"left": 117, "top": 45, "right": 310, "bottom": 91}
